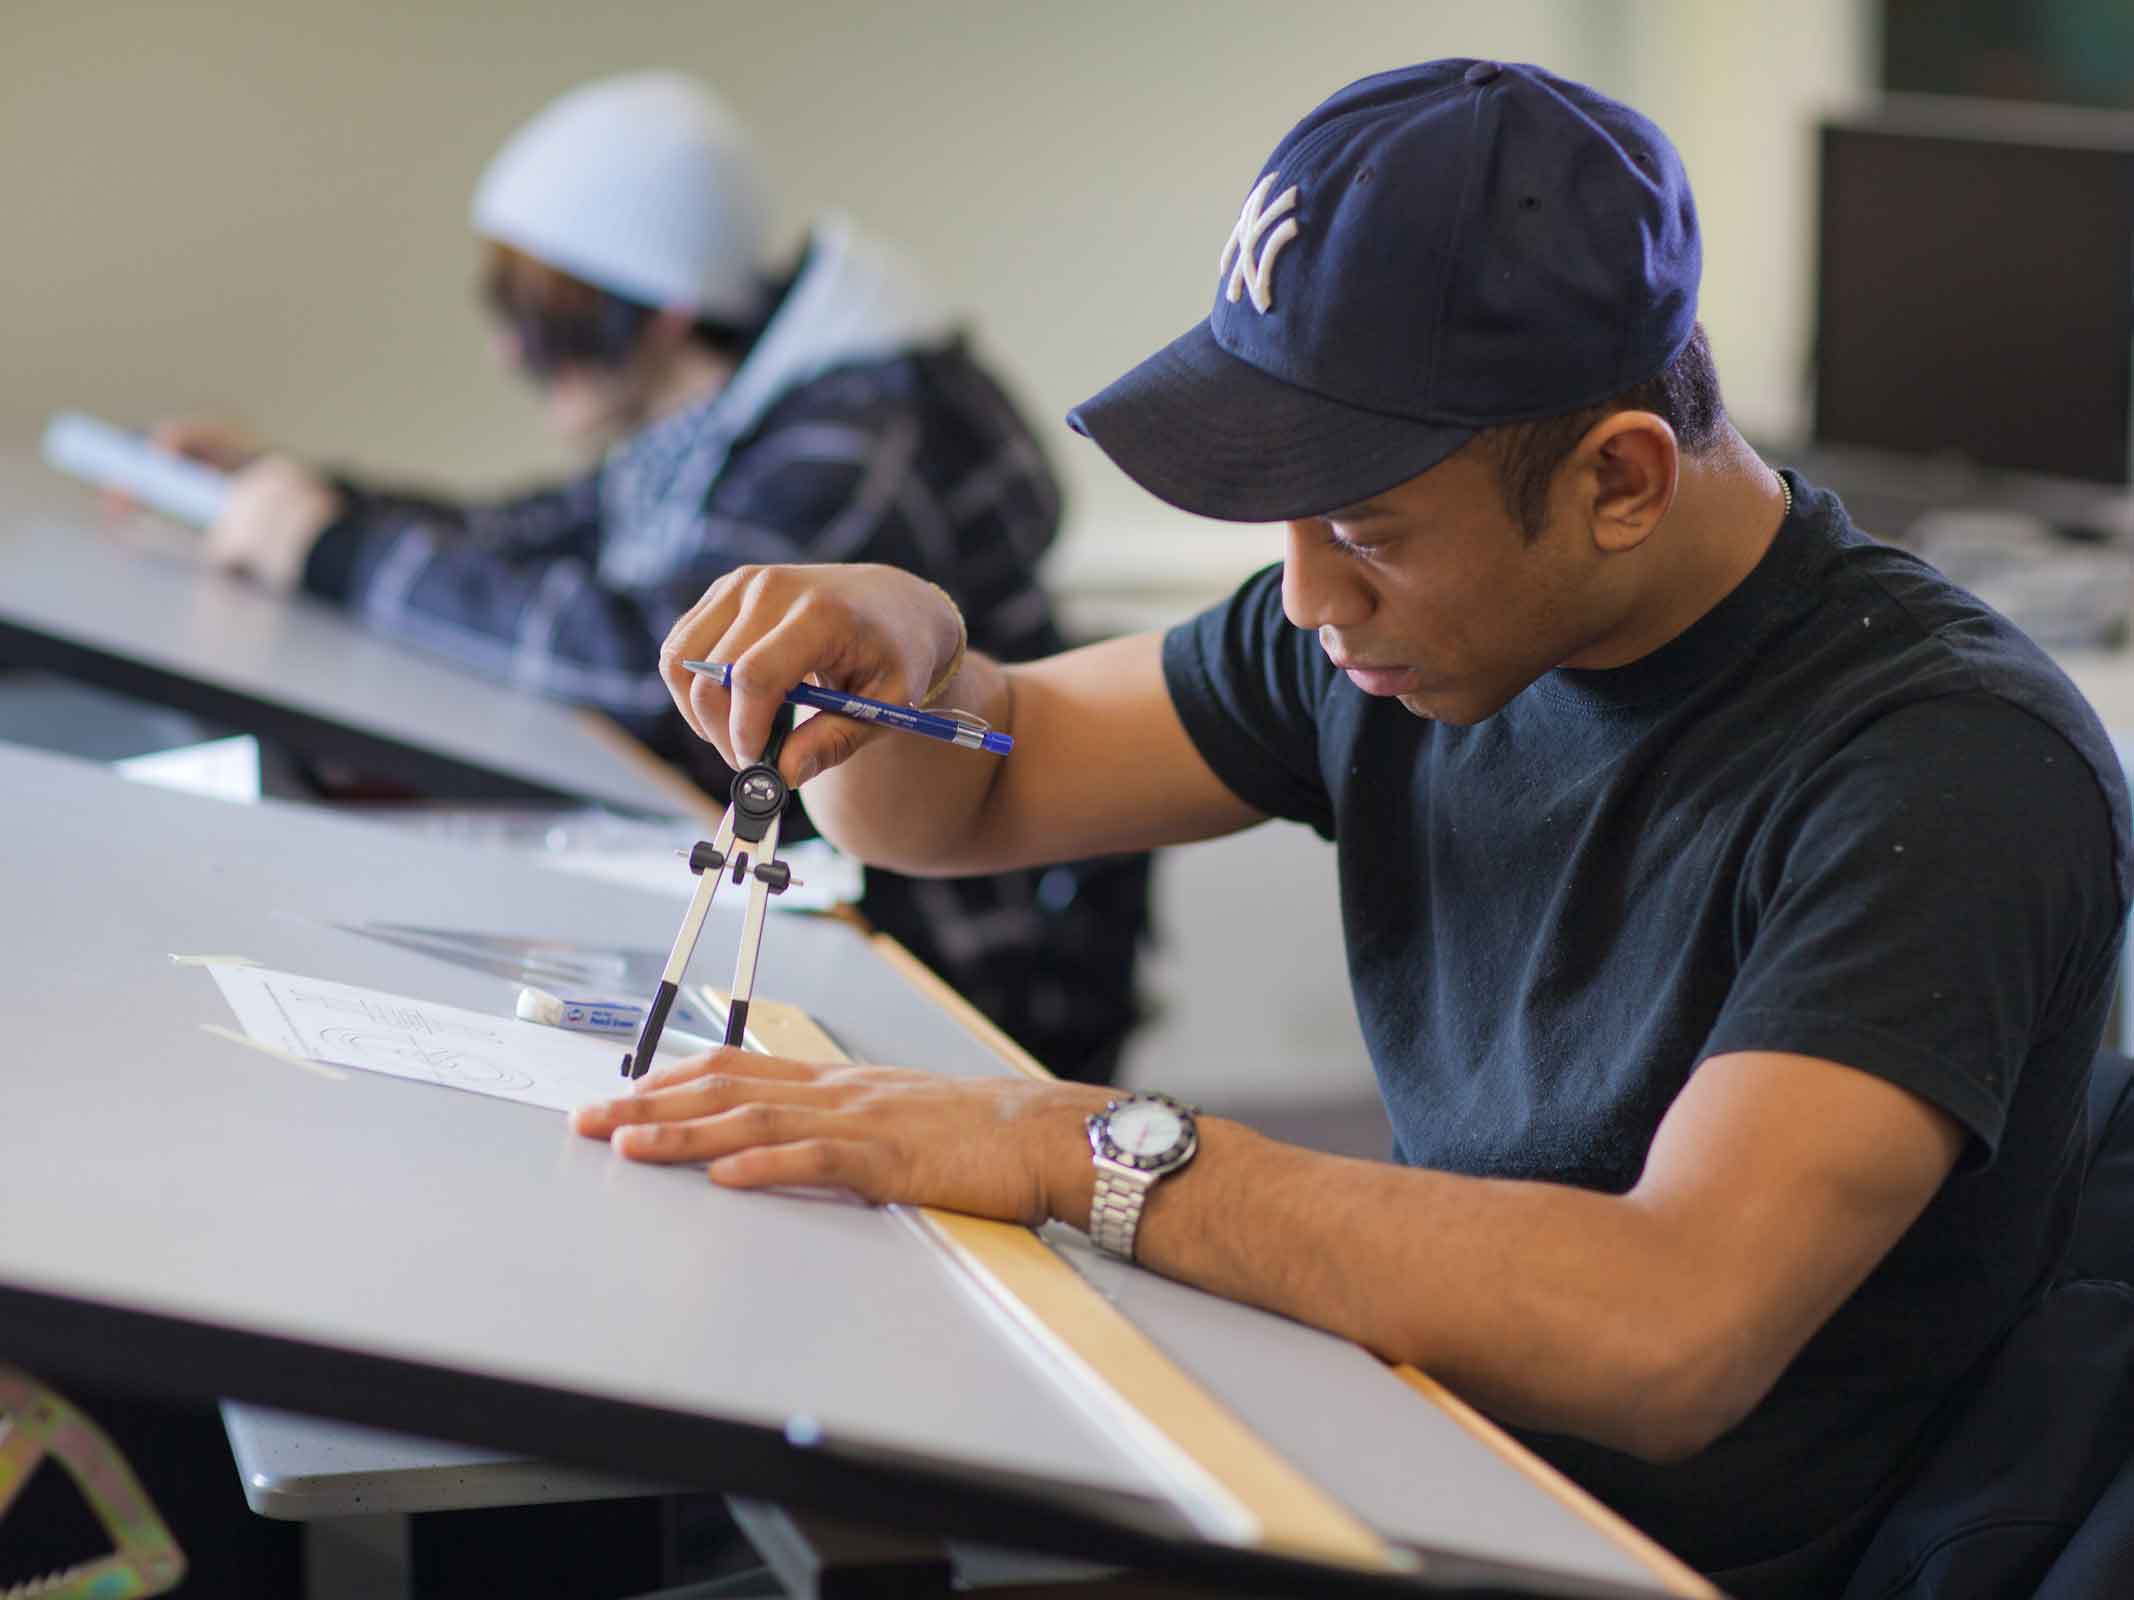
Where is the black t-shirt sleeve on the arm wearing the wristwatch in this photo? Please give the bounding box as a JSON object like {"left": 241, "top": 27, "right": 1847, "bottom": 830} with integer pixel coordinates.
{"left": 1703, "top": 693, "right": 2123, "bottom": 1163}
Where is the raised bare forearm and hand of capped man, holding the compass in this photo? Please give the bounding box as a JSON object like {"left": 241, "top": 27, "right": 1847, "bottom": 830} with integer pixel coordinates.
{"left": 659, "top": 565, "right": 1261, "bottom": 877}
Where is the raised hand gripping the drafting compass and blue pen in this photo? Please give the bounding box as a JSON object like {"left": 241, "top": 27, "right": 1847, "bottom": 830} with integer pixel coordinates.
{"left": 659, "top": 565, "right": 962, "bottom": 785}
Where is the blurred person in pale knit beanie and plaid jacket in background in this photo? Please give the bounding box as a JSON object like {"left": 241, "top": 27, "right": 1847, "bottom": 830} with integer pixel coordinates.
{"left": 160, "top": 73, "right": 1148, "bottom": 1079}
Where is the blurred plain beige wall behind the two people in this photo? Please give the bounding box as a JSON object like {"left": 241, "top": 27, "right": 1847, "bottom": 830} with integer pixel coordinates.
{"left": 0, "top": 0, "right": 1857, "bottom": 584}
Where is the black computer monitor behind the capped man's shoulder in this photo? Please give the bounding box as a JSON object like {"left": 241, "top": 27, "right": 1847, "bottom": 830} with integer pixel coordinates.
{"left": 1814, "top": 96, "right": 2134, "bottom": 486}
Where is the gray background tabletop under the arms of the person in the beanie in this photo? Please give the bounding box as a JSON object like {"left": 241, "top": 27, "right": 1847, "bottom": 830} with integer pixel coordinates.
{"left": 0, "top": 456, "right": 676, "bottom": 815}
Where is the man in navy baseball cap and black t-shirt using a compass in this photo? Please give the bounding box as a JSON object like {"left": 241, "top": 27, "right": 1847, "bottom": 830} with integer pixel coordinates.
{"left": 606, "top": 60, "right": 2128, "bottom": 1596}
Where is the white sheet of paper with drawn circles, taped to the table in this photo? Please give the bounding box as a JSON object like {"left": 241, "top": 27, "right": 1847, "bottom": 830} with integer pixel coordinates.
{"left": 207, "top": 964, "right": 685, "bottom": 1111}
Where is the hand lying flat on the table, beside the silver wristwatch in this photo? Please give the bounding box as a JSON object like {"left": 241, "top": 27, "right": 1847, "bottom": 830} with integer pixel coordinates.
{"left": 570, "top": 1050, "right": 1112, "bottom": 1227}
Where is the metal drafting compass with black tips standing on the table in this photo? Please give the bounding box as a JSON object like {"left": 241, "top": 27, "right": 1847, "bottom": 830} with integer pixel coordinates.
{"left": 623, "top": 704, "right": 794, "bottom": 1077}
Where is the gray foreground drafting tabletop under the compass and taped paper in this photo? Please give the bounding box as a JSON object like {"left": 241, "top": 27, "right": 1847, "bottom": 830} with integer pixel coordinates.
{"left": 0, "top": 747, "right": 1681, "bottom": 1585}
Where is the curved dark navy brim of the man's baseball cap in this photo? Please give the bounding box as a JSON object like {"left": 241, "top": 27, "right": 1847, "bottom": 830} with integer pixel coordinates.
{"left": 1067, "top": 322, "right": 1477, "bottom": 523}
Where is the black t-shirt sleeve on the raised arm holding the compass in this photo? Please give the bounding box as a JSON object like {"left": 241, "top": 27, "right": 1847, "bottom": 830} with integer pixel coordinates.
{"left": 1163, "top": 567, "right": 1334, "bottom": 838}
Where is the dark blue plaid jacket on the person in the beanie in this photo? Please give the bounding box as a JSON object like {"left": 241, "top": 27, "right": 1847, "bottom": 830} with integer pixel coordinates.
{"left": 305, "top": 341, "right": 1148, "bottom": 1077}
